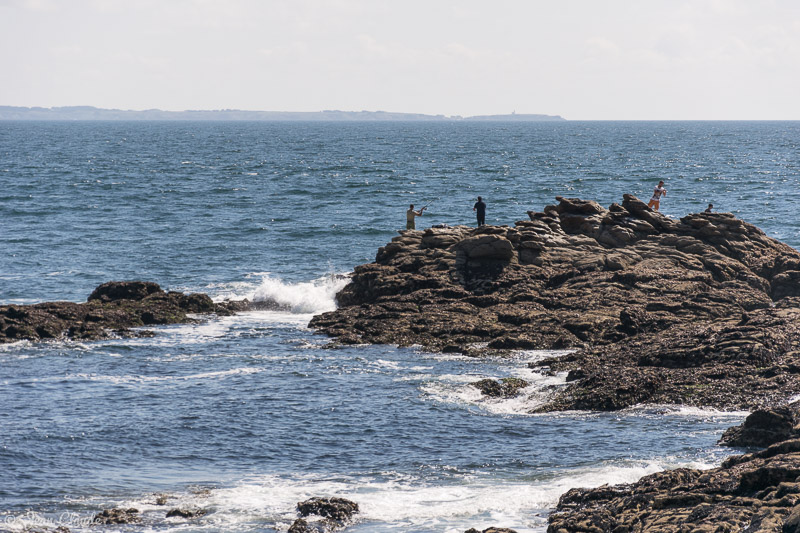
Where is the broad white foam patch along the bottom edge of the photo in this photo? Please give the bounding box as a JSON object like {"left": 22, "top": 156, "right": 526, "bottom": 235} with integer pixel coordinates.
{"left": 97, "top": 457, "right": 715, "bottom": 533}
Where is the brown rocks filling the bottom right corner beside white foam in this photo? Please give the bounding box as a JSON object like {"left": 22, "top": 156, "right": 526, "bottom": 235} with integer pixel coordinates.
{"left": 547, "top": 403, "right": 800, "bottom": 533}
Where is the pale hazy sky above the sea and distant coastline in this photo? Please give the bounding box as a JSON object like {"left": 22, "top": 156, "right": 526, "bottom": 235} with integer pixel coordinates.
{"left": 0, "top": 0, "right": 800, "bottom": 120}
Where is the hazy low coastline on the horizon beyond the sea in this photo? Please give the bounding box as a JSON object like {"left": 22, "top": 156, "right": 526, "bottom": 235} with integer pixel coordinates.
{"left": 0, "top": 106, "right": 566, "bottom": 122}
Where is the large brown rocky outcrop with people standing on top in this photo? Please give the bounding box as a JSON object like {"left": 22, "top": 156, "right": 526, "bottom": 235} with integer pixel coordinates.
{"left": 310, "top": 195, "right": 800, "bottom": 411}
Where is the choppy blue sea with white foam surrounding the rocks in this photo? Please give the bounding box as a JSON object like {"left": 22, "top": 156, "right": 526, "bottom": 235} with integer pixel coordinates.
{"left": 0, "top": 122, "right": 800, "bottom": 533}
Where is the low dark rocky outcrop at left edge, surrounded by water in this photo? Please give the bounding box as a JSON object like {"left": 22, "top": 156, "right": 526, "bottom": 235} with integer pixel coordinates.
{"left": 0, "top": 281, "right": 242, "bottom": 343}
